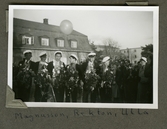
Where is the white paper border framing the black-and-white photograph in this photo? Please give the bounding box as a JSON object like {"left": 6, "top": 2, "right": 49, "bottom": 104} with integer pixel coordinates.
{"left": 8, "top": 5, "right": 159, "bottom": 109}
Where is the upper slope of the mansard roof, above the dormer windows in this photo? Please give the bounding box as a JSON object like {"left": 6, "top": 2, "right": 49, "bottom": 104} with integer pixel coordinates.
{"left": 14, "top": 18, "right": 86, "bottom": 36}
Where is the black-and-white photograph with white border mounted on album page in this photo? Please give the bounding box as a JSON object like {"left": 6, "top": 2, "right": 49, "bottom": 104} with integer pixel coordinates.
{"left": 8, "top": 5, "right": 159, "bottom": 109}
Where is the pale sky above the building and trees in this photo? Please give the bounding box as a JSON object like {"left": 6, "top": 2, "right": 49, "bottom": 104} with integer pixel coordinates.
{"left": 14, "top": 9, "right": 153, "bottom": 49}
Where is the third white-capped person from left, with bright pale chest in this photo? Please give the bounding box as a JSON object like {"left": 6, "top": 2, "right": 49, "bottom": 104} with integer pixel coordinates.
{"left": 47, "top": 51, "right": 65, "bottom": 102}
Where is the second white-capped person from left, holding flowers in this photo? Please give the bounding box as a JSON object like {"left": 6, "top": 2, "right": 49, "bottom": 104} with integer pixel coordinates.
{"left": 34, "top": 51, "right": 56, "bottom": 102}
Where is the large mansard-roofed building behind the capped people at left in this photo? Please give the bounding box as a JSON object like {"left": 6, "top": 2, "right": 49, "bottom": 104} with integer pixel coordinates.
{"left": 13, "top": 18, "right": 92, "bottom": 64}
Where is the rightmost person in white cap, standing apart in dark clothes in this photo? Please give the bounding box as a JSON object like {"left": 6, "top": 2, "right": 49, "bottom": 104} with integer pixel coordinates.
{"left": 137, "top": 57, "right": 148, "bottom": 103}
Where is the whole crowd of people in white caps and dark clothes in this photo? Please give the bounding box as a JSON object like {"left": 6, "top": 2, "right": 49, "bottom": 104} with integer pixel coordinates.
{"left": 13, "top": 50, "right": 153, "bottom": 103}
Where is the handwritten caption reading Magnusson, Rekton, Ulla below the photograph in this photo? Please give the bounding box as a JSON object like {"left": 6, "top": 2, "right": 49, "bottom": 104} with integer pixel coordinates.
{"left": 14, "top": 109, "right": 149, "bottom": 122}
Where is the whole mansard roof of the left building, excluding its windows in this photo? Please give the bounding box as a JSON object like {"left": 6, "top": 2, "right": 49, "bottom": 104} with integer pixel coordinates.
{"left": 14, "top": 18, "right": 92, "bottom": 52}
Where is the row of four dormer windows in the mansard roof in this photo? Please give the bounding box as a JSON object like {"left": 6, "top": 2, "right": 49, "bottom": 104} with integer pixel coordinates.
{"left": 22, "top": 35, "right": 77, "bottom": 48}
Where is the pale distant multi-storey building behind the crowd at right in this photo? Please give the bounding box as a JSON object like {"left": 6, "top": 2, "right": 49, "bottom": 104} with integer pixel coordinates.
{"left": 120, "top": 47, "right": 142, "bottom": 64}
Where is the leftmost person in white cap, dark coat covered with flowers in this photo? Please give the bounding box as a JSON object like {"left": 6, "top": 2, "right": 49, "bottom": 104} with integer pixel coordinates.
{"left": 16, "top": 50, "right": 35, "bottom": 102}
